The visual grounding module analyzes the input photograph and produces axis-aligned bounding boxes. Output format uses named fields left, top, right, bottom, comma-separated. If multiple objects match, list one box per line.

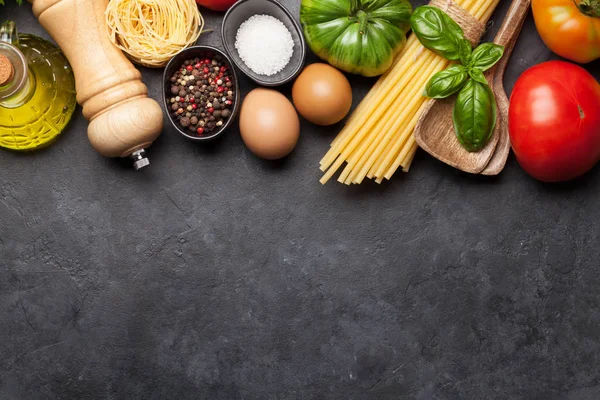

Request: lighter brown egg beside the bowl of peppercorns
left=240, top=88, right=300, bottom=160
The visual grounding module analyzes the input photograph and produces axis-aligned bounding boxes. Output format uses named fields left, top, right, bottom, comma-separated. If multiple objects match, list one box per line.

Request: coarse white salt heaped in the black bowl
left=235, top=14, right=294, bottom=76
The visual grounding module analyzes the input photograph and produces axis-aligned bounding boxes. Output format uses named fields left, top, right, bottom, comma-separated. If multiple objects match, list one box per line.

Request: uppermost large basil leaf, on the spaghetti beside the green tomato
left=410, top=6, right=465, bottom=61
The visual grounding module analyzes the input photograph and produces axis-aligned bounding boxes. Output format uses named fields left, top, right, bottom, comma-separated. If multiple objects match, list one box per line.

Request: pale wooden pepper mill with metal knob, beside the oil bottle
left=29, top=0, right=163, bottom=169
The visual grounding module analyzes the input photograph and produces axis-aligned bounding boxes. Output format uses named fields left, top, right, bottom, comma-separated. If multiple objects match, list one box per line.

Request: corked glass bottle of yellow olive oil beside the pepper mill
left=0, top=21, right=76, bottom=150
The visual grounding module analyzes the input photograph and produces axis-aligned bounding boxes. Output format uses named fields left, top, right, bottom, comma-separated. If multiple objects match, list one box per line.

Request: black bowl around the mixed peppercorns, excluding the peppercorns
left=163, top=46, right=240, bottom=142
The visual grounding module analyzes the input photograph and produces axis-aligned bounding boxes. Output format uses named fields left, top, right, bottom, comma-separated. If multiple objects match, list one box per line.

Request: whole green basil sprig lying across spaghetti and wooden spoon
left=410, top=6, right=504, bottom=152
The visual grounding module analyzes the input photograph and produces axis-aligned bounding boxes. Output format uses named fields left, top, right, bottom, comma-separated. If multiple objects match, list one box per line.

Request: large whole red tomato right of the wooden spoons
left=509, top=61, right=600, bottom=182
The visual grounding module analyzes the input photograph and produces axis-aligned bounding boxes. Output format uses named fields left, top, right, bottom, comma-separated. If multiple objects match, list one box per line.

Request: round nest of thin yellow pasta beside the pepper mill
left=105, top=0, right=204, bottom=68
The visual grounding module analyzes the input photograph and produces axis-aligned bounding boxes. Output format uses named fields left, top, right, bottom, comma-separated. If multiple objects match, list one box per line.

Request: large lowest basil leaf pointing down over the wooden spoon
left=452, top=79, right=497, bottom=152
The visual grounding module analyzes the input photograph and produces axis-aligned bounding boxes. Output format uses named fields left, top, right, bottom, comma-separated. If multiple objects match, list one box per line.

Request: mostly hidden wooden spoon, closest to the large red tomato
left=481, top=0, right=531, bottom=176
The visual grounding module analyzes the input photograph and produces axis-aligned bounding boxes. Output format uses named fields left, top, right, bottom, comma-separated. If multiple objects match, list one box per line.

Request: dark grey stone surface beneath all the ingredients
left=0, top=0, right=600, bottom=400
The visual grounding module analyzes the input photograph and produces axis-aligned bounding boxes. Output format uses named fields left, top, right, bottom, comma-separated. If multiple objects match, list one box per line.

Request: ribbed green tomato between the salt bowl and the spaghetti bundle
left=300, top=0, right=412, bottom=76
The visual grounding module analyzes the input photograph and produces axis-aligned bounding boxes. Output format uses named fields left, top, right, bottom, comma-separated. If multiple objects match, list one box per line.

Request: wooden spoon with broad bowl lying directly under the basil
left=415, top=0, right=531, bottom=174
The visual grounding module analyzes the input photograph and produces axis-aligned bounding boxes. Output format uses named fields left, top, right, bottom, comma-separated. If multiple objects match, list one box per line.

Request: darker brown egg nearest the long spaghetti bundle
left=292, top=63, right=352, bottom=125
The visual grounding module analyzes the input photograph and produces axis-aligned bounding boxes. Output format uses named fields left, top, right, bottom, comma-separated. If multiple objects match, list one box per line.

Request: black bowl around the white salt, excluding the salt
left=221, top=0, right=306, bottom=86
